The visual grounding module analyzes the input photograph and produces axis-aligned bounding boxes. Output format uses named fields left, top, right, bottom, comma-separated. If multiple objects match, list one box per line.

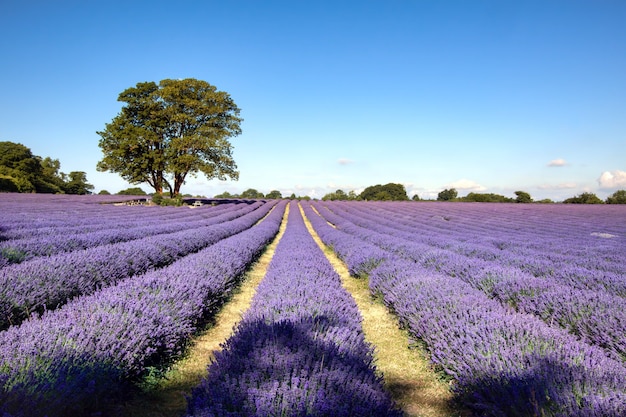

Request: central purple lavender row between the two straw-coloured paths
left=188, top=203, right=401, bottom=417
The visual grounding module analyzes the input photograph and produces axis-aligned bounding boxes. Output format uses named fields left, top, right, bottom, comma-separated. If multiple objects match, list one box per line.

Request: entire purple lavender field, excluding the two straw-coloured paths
left=0, top=194, right=626, bottom=417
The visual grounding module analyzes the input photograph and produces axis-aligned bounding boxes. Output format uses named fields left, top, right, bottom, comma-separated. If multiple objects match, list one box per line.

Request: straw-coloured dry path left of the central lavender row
left=117, top=205, right=289, bottom=417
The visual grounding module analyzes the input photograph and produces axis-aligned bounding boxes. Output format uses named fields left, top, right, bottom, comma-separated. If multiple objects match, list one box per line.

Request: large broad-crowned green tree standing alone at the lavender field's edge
left=97, top=78, right=242, bottom=197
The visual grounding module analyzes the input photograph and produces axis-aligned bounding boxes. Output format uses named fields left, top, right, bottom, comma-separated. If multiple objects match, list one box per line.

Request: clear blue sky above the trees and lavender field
left=0, top=0, right=626, bottom=200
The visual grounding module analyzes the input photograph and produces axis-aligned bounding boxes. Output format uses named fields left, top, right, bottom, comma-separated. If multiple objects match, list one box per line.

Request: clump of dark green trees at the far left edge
left=0, top=142, right=94, bottom=194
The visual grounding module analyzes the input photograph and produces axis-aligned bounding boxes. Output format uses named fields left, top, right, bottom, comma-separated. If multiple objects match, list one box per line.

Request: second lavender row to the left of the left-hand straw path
left=0, top=202, right=273, bottom=330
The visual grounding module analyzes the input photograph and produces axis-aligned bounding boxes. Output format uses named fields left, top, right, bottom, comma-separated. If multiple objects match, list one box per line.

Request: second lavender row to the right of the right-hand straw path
left=320, top=204, right=626, bottom=360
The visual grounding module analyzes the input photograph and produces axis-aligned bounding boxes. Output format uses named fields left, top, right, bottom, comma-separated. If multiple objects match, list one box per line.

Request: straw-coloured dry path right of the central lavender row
left=300, top=204, right=465, bottom=417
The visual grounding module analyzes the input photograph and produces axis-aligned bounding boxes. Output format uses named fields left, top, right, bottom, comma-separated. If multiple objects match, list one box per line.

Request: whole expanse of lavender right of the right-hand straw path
left=305, top=202, right=626, bottom=417
